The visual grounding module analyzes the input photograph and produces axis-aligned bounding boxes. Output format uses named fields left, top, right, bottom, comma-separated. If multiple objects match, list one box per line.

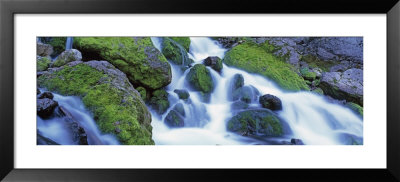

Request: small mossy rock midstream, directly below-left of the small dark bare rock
left=186, top=64, right=214, bottom=94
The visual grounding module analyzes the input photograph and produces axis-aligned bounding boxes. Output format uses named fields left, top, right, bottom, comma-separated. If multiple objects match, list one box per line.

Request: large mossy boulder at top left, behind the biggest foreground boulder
left=74, top=37, right=172, bottom=90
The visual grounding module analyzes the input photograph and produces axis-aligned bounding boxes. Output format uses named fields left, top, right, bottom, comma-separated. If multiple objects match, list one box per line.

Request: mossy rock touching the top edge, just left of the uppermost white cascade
left=162, top=37, right=193, bottom=67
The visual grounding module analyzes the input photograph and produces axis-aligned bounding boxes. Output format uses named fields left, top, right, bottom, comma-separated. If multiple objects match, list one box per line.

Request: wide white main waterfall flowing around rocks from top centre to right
left=151, top=37, right=363, bottom=145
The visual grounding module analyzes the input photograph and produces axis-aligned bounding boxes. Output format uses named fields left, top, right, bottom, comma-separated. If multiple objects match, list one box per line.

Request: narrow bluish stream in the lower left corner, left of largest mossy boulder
left=37, top=90, right=119, bottom=145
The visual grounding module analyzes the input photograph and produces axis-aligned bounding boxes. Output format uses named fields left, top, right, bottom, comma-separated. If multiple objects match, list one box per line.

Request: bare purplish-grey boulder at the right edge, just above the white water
left=319, top=68, right=363, bottom=105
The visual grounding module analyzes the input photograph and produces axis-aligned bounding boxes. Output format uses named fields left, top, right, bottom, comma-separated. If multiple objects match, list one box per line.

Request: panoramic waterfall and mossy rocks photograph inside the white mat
left=36, top=36, right=364, bottom=145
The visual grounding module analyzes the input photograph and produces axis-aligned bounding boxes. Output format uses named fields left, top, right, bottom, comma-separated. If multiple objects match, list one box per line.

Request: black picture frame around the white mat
left=0, top=0, right=400, bottom=181
